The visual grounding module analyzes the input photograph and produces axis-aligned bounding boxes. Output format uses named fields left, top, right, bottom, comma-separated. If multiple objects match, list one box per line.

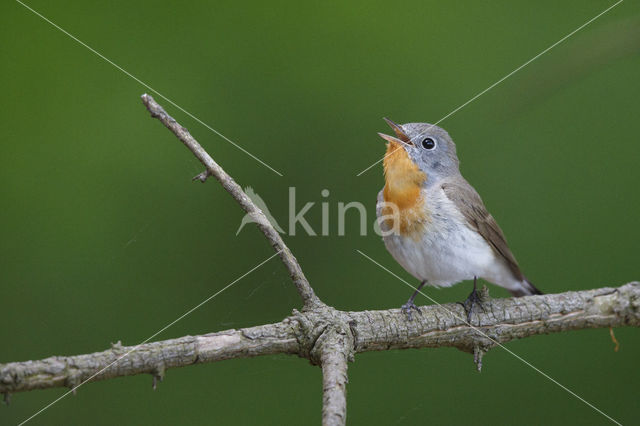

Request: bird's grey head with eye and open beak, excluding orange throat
left=379, top=118, right=460, bottom=183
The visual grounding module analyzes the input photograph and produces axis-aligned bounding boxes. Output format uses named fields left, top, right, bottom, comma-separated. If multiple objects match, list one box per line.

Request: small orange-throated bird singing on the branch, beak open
left=376, top=118, right=542, bottom=322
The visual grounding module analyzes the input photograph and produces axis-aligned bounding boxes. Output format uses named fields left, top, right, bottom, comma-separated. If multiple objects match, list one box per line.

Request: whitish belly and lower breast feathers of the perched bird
left=383, top=187, right=517, bottom=287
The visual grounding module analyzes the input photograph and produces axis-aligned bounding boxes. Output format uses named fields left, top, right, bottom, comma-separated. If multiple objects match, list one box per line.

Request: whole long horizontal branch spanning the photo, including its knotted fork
left=0, top=282, right=640, bottom=396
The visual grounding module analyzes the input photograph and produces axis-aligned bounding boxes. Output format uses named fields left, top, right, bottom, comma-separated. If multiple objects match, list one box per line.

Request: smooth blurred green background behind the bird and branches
left=0, top=0, right=640, bottom=425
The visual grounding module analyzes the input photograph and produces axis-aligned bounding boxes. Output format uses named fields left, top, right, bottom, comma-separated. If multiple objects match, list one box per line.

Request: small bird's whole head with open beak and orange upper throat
left=378, top=118, right=459, bottom=184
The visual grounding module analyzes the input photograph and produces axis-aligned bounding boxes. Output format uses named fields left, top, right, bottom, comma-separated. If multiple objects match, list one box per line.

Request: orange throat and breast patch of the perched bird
left=382, top=142, right=428, bottom=239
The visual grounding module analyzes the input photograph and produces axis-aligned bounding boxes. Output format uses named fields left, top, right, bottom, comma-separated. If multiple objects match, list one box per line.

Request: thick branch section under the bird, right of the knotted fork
left=349, top=282, right=640, bottom=360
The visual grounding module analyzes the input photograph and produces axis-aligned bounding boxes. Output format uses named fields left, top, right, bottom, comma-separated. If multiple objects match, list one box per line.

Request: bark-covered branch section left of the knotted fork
left=0, top=321, right=299, bottom=393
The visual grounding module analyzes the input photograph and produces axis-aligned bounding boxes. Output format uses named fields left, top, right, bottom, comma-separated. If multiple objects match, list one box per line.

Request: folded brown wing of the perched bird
left=442, top=177, right=524, bottom=280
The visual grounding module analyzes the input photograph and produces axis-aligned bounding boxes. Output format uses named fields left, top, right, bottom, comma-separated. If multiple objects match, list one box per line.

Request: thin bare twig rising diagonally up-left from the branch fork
left=142, top=93, right=322, bottom=309
